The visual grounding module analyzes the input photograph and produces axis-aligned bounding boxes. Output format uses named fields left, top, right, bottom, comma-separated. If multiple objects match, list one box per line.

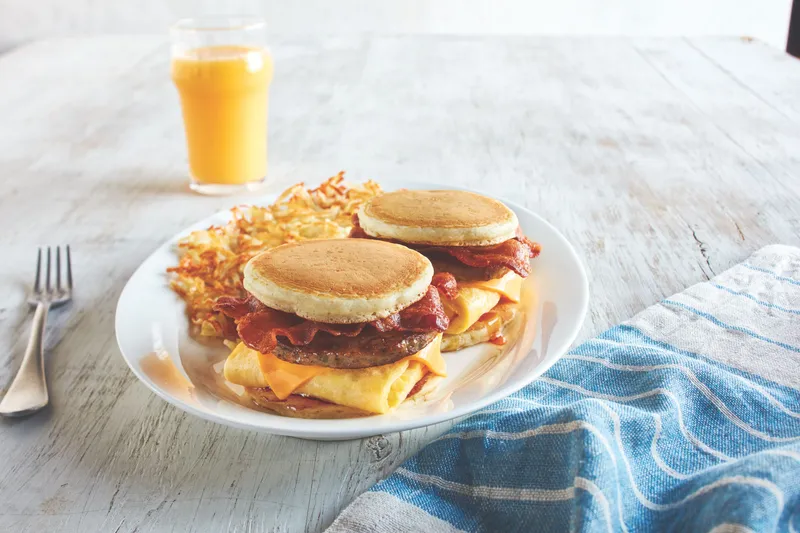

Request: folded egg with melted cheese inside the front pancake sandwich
left=224, top=335, right=447, bottom=413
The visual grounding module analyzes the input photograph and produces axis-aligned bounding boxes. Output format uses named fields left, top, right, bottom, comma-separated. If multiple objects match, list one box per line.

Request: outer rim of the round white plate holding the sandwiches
left=114, top=179, right=589, bottom=440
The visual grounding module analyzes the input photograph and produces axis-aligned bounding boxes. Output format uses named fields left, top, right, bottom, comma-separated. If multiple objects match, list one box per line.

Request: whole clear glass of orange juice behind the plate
left=171, top=16, right=272, bottom=194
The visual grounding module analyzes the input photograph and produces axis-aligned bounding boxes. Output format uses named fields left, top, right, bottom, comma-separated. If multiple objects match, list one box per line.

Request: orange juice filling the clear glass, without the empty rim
left=172, top=46, right=272, bottom=185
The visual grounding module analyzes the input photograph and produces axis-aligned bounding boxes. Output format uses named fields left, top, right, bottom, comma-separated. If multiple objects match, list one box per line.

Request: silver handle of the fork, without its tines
left=0, top=302, right=50, bottom=416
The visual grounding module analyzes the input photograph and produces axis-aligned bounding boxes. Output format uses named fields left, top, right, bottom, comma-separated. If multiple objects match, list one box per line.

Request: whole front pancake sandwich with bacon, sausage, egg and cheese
left=215, top=239, right=449, bottom=418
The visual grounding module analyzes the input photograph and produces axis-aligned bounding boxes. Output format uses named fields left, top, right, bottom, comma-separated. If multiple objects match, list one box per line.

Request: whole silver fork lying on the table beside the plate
left=0, top=246, right=72, bottom=416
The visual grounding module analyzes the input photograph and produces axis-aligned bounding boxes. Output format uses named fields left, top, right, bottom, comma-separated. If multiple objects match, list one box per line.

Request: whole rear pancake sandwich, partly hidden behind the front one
left=350, top=190, right=541, bottom=351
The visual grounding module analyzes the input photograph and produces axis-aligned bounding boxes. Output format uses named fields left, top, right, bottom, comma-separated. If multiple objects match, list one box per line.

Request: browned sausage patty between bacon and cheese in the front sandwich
left=273, top=329, right=438, bottom=368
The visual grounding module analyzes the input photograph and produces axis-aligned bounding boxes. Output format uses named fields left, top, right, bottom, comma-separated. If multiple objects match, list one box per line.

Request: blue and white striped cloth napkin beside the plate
left=328, top=246, right=800, bottom=533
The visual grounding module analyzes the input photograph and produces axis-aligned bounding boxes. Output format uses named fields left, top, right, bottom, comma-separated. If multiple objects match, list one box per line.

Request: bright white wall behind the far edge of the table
left=0, top=0, right=791, bottom=49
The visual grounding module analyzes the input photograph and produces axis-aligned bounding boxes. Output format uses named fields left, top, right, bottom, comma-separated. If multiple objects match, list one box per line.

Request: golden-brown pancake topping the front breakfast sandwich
left=244, top=239, right=433, bottom=324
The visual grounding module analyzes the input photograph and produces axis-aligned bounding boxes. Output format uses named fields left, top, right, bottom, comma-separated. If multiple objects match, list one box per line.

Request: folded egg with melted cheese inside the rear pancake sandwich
left=442, top=272, right=522, bottom=335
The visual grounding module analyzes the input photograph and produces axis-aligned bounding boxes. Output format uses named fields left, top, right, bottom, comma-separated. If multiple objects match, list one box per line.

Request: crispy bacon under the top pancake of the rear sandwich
left=350, top=213, right=542, bottom=278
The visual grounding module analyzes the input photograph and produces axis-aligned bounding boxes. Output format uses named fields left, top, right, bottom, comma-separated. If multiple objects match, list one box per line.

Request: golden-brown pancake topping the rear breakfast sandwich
left=358, top=190, right=519, bottom=246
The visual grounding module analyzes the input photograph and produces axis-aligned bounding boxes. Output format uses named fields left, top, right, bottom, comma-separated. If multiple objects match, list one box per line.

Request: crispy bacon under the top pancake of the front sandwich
left=214, top=286, right=450, bottom=353
